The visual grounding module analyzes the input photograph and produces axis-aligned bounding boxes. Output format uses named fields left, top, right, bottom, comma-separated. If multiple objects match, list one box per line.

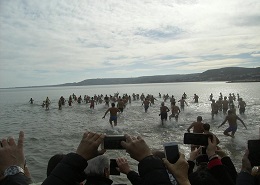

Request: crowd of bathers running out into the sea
left=26, top=92, right=250, bottom=140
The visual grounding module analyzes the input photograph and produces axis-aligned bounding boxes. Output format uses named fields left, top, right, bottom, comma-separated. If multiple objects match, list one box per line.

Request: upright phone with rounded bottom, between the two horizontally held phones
left=163, top=142, right=180, bottom=164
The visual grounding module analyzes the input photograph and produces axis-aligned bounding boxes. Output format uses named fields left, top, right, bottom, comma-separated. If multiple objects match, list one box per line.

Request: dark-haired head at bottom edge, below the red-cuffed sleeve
left=189, top=170, right=220, bottom=185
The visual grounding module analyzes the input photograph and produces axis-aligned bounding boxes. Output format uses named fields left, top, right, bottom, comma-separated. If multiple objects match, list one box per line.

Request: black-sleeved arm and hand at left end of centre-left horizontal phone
left=42, top=132, right=105, bottom=185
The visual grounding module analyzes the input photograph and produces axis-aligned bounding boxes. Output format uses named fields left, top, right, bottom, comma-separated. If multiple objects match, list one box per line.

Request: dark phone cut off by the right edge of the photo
left=247, top=139, right=260, bottom=167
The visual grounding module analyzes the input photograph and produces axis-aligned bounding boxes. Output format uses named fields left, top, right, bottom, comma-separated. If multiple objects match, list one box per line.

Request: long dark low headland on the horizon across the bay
left=6, top=67, right=260, bottom=88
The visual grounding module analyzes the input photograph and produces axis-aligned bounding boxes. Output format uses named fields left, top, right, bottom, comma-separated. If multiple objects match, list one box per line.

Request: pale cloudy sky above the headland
left=0, top=0, right=260, bottom=88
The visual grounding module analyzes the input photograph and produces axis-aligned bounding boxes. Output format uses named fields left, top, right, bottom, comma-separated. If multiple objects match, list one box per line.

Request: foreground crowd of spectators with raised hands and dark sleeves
left=0, top=131, right=260, bottom=185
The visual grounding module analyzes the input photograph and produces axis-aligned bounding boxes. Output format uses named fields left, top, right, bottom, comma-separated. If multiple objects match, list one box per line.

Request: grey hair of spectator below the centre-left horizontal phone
left=84, top=155, right=110, bottom=176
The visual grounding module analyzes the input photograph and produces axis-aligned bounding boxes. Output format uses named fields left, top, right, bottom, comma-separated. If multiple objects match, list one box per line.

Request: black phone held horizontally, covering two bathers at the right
left=183, top=133, right=213, bottom=146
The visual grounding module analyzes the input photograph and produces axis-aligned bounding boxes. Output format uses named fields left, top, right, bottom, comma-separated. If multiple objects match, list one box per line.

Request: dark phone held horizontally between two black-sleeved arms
left=101, top=135, right=126, bottom=150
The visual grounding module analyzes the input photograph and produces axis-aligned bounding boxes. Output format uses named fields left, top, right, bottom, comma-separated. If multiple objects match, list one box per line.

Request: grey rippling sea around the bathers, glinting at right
left=0, top=82, right=260, bottom=184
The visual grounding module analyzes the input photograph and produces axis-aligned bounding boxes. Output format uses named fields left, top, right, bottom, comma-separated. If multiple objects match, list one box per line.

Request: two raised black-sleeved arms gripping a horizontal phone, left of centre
left=42, top=132, right=171, bottom=185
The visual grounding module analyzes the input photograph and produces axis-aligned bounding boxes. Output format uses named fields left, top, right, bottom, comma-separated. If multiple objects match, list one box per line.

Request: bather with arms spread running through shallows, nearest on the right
left=218, top=110, right=247, bottom=138
